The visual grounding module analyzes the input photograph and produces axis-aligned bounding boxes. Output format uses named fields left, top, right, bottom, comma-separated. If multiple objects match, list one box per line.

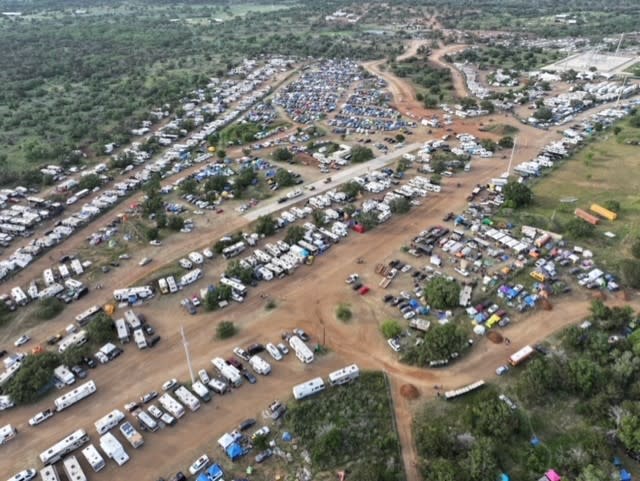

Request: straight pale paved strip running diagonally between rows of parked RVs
left=244, top=142, right=423, bottom=221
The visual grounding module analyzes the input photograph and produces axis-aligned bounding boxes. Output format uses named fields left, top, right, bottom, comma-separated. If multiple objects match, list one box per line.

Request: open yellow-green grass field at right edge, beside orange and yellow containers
left=504, top=121, right=640, bottom=270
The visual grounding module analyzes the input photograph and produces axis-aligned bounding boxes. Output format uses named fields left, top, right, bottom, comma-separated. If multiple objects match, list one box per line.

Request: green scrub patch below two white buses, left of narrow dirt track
left=285, top=372, right=405, bottom=481
